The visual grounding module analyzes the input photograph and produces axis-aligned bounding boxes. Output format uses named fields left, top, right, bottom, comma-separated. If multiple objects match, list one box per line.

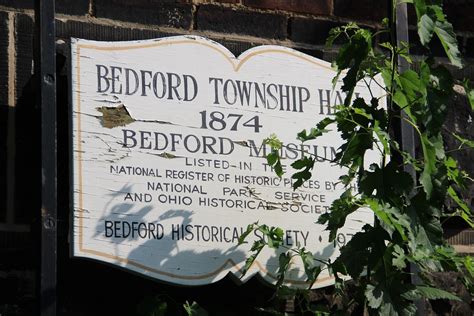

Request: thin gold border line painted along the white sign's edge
left=76, top=39, right=334, bottom=285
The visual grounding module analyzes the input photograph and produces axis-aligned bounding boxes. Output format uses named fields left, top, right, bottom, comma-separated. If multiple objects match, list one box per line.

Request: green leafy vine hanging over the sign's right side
left=240, top=0, right=474, bottom=315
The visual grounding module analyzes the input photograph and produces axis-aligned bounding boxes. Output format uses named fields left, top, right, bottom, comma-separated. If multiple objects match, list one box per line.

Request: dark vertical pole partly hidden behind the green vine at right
left=389, top=1, right=426, bottom=315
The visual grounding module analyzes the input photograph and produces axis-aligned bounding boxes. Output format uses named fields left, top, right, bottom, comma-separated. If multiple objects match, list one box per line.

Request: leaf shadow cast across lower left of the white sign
left=94, top=184, right=247, bottom=285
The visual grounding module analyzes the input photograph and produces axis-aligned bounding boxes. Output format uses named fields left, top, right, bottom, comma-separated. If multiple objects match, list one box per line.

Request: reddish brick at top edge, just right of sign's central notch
left=242, top=0, right=332, bottom=15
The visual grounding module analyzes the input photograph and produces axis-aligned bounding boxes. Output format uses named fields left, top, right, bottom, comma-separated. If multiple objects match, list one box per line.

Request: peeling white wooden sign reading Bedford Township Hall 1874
left=71, top=36, right=382, bottom=287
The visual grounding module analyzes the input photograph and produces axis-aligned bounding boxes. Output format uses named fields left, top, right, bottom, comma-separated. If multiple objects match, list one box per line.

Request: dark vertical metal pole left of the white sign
left=35, top=0, right=57, bottom=316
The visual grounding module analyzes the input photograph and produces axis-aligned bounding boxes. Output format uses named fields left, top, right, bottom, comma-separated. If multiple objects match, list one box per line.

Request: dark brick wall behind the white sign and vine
left=0, top=0, right=474, bottom=313
